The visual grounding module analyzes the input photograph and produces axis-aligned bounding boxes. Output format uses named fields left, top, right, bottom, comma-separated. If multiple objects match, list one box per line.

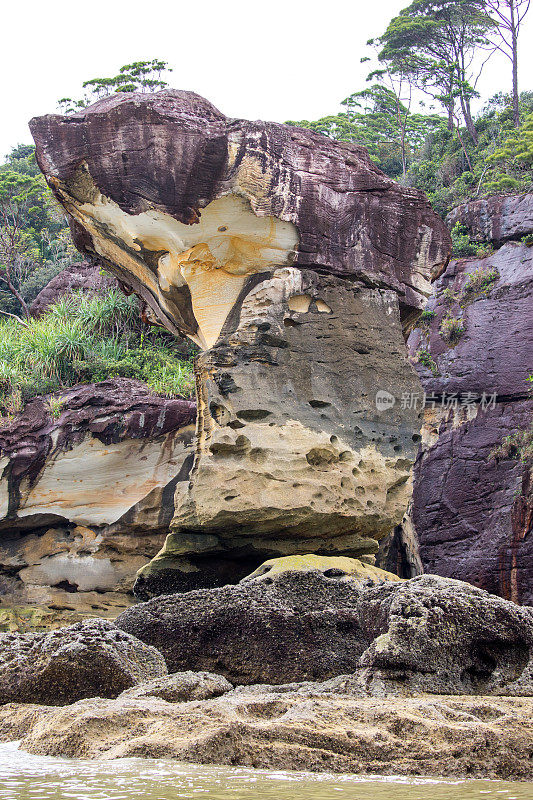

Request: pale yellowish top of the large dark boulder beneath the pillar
left=243, top=554, right=401, bottom=583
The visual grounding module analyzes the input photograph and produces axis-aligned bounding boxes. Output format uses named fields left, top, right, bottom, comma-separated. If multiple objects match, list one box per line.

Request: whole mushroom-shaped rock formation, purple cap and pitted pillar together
left=31, top=91, right=450, bottom=591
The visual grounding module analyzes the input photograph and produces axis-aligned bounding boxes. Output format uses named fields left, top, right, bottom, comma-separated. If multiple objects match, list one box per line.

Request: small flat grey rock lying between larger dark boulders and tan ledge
left=120, top=671, right=233, bottom=703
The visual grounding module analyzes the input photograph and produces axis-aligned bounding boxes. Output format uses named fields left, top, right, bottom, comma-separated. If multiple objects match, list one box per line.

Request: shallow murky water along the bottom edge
left=0, top=743, right=533, bottom=800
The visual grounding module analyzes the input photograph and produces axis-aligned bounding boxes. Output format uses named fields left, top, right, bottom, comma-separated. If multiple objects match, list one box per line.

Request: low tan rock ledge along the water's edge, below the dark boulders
left=0, top=692, right=533, bottom=780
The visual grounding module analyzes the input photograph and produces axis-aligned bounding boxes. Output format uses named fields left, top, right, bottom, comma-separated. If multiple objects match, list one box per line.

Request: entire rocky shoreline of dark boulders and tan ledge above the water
left=0, top=559, right=533, bottom=780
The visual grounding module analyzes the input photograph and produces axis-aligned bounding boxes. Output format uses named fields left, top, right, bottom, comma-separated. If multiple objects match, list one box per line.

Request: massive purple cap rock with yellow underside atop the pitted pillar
left=30, top=89, right=449, bottom=328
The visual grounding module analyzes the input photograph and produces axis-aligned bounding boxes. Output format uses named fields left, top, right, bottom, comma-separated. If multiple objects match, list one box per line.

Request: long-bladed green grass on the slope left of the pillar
left=0, top=290, right=193, bottom=419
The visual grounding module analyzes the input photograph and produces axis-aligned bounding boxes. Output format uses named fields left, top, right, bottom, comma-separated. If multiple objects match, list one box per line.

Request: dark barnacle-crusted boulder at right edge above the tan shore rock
left=360, top=575, right=533, bottom=695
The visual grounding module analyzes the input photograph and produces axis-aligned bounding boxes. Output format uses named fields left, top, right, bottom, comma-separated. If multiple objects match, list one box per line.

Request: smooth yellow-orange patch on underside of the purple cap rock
left=57, top=174, right=298, bottom=348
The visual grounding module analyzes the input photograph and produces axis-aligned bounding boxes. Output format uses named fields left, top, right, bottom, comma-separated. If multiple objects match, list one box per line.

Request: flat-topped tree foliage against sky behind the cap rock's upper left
left=57, top=58, right=172, bottom=114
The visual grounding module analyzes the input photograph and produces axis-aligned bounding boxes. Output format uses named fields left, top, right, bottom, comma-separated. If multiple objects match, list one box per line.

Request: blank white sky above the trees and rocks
left=0, top=0, right=533, bottom=157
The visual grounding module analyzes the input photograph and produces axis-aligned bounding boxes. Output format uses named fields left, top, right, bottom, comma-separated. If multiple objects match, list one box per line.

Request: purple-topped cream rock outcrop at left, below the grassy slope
left=0, top=379, right=196, bottom=627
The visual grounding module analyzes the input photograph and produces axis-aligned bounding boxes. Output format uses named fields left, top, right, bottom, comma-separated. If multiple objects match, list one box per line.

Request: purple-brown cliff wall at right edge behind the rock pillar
left=404, top=203, right=533, bottom=605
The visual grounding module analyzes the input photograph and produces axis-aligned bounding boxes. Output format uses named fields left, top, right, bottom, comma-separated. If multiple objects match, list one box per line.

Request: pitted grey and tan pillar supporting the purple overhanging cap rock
left=135, top=268, right=421, bottom=599
